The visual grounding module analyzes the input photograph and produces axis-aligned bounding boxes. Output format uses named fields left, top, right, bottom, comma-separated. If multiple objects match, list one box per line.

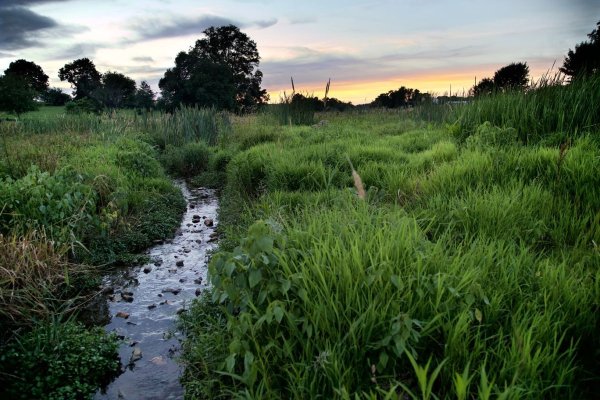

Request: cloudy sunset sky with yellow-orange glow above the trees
left=0, top=0, right=600, bottom=104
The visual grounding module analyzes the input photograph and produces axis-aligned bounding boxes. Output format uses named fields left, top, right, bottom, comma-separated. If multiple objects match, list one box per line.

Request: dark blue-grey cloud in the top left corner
left=0, top=7, right=59, bottom=50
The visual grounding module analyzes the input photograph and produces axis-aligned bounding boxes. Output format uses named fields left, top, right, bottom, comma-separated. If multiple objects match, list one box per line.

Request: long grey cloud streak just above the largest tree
left=128, top=15, right=277, bottom=42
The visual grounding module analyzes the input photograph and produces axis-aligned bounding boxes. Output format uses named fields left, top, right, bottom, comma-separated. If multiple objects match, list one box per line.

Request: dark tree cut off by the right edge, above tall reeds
left=560, top=21, right=600, bottom=78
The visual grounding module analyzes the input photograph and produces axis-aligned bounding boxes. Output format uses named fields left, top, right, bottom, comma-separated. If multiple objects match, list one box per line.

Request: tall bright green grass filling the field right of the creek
left=182, top=81, right=600, bottom=399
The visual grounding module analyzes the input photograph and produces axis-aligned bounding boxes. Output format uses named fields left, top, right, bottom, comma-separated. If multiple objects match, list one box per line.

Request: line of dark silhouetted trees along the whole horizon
left=0, top=21, right=600, bottom=114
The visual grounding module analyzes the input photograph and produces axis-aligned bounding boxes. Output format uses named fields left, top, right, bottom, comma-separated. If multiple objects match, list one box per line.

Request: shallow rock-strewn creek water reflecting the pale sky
left=94, top=182, right=217, bottom=400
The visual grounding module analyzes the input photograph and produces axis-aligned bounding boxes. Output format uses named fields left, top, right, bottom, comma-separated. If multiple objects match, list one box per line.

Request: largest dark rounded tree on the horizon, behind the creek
left=159, top=25, right=268, bottom=111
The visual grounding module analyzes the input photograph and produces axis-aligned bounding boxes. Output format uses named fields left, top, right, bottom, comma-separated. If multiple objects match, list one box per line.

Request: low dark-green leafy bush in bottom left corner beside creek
left=0, top=321, right=119, bottom=400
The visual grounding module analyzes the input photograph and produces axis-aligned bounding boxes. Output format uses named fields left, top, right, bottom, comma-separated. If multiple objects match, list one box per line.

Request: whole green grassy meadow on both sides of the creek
left=0, top=77, right=600, bottom=399
